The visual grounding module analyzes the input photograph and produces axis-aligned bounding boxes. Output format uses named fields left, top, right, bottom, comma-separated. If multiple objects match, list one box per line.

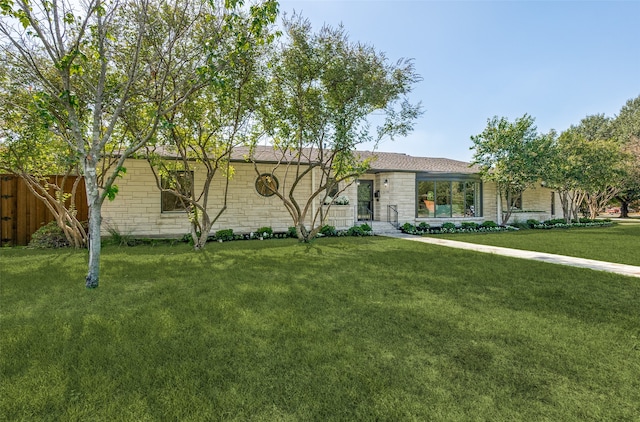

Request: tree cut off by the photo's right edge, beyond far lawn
left=613, top=96, right=640, bottom=218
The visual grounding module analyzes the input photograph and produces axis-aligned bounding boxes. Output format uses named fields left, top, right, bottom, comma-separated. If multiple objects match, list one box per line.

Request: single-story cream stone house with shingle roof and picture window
left=102, top=146, right=561, bottom=237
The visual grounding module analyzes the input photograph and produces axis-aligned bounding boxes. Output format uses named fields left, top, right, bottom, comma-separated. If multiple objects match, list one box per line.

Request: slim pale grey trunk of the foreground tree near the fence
left=85, top=163, right=102, bottom=289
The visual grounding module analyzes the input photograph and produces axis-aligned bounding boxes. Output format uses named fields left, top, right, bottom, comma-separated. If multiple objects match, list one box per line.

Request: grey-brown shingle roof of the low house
left=146, top=145, right=480, bottom=174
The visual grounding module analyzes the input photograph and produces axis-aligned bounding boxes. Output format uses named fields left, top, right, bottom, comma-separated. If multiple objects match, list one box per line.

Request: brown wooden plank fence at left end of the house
left=0, top=175, right=89, bottom=246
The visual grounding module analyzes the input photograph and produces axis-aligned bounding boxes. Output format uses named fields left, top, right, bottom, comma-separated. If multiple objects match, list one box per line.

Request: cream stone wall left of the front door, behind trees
left=102, top=159, right=356, bottom=237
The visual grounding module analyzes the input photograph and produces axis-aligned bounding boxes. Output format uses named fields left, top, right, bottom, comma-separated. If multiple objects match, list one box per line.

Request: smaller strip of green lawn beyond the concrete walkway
left=436, top=224, right=640, bottom=266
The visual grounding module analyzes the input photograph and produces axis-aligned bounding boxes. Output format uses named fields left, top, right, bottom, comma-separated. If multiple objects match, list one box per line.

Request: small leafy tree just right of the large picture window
left=471, top=114, right=555, bottom=223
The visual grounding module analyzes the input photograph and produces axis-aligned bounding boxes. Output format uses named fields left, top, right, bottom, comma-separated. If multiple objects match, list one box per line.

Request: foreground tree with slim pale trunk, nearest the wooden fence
left=0, top=0, right=228, bottom=288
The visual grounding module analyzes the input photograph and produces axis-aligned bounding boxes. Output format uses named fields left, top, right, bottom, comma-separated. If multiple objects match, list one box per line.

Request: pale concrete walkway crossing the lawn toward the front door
left=383, top=233, right=640, bottom=278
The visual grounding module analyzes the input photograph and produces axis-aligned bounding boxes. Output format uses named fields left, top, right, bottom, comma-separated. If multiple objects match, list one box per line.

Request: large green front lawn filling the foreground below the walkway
left=0, top=238, right=640, bottom=421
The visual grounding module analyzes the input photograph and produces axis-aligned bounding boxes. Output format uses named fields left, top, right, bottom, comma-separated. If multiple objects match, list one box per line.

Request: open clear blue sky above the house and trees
left=280, top=0, right=640, bottom=161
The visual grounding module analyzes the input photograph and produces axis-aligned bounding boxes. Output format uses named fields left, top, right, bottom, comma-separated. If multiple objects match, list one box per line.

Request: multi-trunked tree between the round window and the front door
left=253, top=16, right=421, bottom=242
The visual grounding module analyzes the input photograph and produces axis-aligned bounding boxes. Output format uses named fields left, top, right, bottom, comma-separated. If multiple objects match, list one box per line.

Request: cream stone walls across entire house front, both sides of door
left=102, top=159, right=562, bottom=237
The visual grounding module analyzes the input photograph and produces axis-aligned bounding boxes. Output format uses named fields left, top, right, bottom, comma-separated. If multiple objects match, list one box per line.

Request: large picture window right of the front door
left=417, top=178, right=482, bottom=218
